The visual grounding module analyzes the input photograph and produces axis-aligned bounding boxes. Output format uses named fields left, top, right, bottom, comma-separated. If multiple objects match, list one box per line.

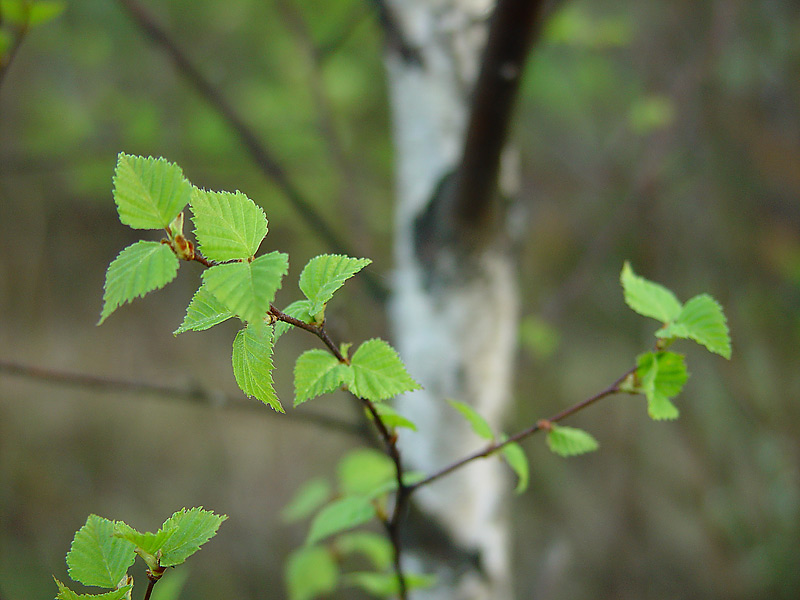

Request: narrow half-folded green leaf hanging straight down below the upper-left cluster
left=233, top=323, right=285, bottom=412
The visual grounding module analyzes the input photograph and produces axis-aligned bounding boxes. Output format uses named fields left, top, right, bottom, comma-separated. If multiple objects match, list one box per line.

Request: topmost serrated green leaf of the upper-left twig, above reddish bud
left=114, top=152, right=192, bottom=229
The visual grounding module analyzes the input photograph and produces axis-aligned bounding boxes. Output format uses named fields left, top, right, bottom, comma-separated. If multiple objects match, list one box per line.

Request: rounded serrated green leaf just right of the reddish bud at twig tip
left=190, top=188, right=268, bottom=261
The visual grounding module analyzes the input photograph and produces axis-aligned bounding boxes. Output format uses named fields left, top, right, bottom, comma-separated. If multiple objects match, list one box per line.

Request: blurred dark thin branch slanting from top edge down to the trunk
left=119, top=0, right=388, bottom=302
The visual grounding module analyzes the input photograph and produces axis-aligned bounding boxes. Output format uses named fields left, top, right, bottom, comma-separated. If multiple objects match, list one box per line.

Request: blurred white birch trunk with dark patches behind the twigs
left=387, top=0, right=518, bottom=600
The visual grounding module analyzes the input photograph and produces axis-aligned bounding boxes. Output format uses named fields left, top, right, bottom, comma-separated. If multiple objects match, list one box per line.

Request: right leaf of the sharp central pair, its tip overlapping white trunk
left=349, top=338, right=420, bottom=402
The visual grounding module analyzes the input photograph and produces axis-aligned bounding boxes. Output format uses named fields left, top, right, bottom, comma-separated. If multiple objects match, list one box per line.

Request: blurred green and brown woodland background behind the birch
left=0, top=0, right=800, bottom=600
